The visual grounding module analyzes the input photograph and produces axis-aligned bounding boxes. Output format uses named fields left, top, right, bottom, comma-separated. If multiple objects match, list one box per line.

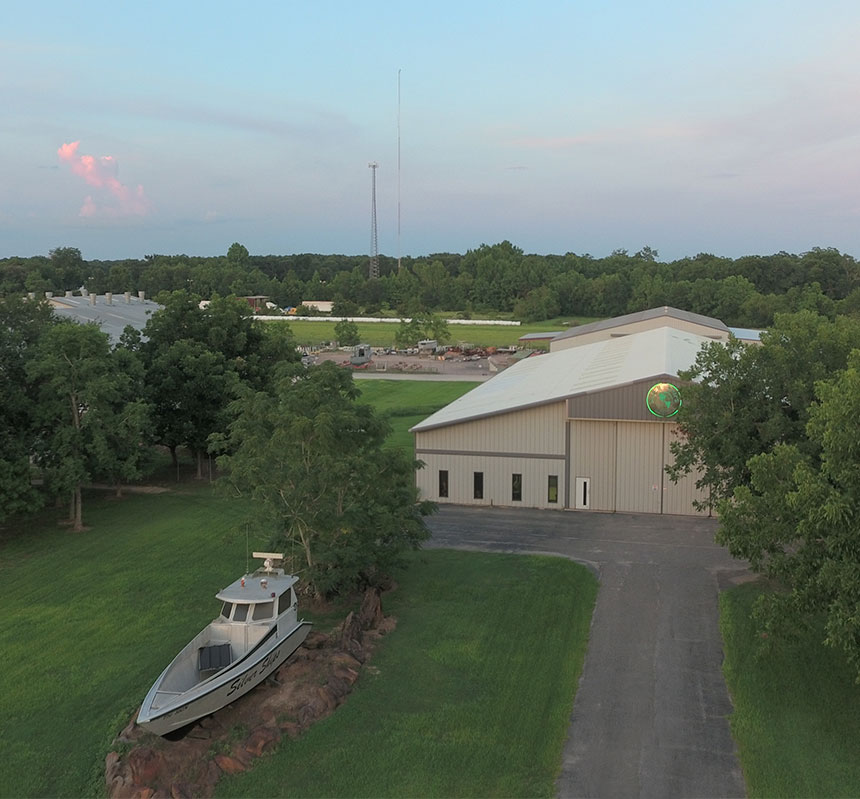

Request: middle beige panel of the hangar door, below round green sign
left=615, top=422, right=664, bottom=513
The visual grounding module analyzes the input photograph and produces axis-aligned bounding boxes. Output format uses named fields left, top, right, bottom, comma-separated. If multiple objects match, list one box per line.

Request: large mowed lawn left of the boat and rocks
left=0, top=486, right=268, bottom=796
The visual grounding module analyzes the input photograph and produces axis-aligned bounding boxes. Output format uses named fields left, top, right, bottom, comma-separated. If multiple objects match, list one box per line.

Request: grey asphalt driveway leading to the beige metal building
left=429, top=505, right=747, bottom=799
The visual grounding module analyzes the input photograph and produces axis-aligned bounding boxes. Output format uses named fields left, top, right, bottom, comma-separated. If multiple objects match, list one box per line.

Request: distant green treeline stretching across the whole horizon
left=0, top=241, right=860, bottom=327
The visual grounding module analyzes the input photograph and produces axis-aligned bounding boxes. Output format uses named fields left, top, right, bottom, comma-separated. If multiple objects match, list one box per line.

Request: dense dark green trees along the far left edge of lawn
left=0, top=292, right=298, bottom=530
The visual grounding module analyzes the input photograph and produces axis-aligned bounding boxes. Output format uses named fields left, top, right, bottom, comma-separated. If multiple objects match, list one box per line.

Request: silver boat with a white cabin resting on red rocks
left=137, top=552, right=312, bottom=735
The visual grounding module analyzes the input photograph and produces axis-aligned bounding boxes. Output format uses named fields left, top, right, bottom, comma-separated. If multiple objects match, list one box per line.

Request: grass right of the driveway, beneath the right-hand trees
left=720, top=584, right=860, bottom=797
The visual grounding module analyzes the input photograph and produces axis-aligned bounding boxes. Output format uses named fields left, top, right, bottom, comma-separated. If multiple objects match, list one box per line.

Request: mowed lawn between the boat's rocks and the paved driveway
left=217, top=550, right=597, bottom=797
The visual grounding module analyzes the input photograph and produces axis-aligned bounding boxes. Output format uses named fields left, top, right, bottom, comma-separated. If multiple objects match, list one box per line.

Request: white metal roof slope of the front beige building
left=411, top=327, right=713, bottom=432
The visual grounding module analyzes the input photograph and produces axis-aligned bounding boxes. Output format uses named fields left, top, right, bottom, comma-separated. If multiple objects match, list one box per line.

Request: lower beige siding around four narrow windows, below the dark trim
left=417, top=454, right=565, bottom=508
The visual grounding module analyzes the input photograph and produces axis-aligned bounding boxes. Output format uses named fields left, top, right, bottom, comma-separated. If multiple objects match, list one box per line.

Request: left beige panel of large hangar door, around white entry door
left=569, top=419, right=616, bottom=511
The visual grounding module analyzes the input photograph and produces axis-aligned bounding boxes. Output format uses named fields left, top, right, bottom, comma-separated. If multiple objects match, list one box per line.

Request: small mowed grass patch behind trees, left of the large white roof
left=355, top=378, right=480, bottom=452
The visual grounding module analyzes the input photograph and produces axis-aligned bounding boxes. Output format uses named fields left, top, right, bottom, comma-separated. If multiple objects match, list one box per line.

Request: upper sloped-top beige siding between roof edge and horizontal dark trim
left=415, top=400, right=567, bottom=455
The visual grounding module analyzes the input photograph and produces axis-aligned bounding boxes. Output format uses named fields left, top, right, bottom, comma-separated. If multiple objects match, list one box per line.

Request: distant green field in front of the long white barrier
left=266, top=319, right=593, bottom=347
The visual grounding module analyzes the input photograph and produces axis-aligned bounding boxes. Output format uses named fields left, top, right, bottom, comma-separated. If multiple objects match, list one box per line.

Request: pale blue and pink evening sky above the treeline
left=0, top=0, right=860, bottom=260
